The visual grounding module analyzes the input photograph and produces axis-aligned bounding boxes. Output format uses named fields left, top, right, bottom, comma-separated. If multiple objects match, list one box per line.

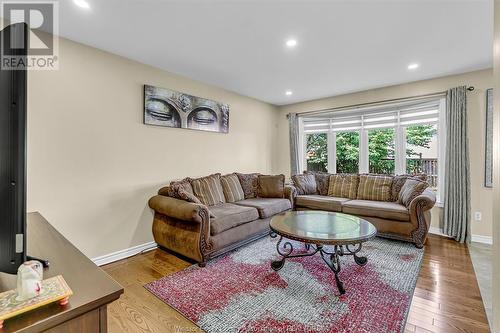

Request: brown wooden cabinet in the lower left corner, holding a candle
left=0, top=213, right=123, bottom=333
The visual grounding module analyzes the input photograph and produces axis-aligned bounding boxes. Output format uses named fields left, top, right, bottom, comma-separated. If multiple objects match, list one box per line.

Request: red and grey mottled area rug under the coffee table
left=145, top=237, right=423, bottom=333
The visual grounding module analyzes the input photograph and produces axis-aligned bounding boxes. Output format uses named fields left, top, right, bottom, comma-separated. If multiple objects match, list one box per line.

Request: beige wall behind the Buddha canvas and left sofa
left=28, top=39, right=278, bottom=257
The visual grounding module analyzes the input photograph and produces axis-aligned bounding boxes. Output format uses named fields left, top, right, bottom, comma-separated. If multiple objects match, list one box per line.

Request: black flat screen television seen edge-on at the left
left=0, top=23, right=28, bottom=274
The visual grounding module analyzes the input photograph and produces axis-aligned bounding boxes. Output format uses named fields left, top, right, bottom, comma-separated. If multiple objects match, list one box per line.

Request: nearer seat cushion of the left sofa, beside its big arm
left=210, top=203, right=259, bottom=236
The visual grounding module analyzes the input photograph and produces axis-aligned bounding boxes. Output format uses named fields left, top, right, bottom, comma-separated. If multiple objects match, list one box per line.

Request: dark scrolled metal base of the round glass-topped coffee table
left=271, top=233, right=368, bottom=295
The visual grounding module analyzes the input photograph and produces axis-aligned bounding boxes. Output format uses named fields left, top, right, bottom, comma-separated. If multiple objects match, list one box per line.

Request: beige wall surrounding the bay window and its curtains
left=275, top=69, right=493, bottom=236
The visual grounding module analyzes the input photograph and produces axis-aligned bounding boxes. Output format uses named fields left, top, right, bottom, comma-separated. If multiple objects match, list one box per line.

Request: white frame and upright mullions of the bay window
left=299, top=97, right=446, bottom=202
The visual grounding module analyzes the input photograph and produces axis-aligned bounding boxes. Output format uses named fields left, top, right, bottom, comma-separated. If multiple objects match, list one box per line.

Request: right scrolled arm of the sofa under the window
left=409, top=189, right=436, bottom=248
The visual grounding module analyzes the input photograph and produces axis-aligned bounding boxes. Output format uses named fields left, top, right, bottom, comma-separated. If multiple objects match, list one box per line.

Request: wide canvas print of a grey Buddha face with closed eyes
left=144, top=85, right=229, bottom=133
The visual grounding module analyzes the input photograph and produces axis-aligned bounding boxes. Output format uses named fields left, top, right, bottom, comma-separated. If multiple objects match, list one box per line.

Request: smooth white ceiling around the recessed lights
left=54, top=0, right=493, bottom=105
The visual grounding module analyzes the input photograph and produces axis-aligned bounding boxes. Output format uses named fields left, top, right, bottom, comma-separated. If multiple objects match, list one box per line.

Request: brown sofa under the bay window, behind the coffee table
left=292, top=172, right=436, bottom=248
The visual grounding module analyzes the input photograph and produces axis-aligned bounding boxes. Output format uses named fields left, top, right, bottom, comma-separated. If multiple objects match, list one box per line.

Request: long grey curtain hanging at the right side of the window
left=443, top=86, right=471, bottom=243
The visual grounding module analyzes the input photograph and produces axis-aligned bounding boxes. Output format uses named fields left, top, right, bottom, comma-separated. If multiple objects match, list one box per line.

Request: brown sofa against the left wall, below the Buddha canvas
left=149, top=173, right=294, bottom=266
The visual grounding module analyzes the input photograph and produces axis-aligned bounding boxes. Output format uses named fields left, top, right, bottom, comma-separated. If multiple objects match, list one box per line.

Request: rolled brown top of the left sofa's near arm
left=149, top=195, right=208, bottom=223
